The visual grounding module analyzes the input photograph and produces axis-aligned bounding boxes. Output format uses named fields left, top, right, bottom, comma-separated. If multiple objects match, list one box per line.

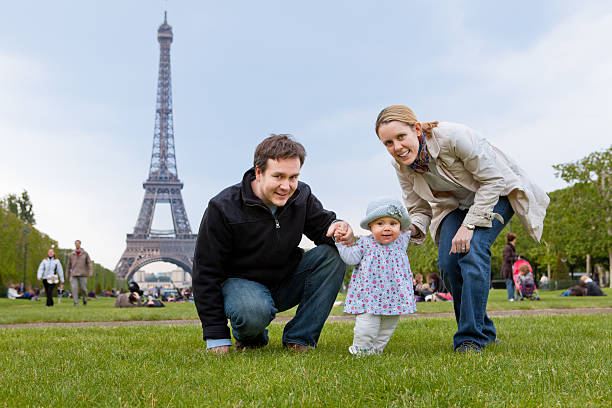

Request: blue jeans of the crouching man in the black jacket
left=222, top=245, right=346, bottom=347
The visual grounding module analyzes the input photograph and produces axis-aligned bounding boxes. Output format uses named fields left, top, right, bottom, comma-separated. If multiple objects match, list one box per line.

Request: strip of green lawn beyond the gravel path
left=0, top=289, right=612, bottom=324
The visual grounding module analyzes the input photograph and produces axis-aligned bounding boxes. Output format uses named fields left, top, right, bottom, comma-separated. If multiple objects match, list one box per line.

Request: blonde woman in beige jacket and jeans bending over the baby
left=376, top=105, right=549, bottom=352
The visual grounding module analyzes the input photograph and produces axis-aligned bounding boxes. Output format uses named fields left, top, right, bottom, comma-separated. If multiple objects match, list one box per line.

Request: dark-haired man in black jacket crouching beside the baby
left=193, top=135, right=353, bottom=354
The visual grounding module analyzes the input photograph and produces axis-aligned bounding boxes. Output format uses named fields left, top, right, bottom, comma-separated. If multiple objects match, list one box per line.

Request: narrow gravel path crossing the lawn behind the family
left=0, top=307, right=612, bottom=329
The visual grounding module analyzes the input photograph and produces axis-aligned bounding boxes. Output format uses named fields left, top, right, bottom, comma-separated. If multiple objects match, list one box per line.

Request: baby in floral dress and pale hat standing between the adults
left=334, top=198, right=416, bottom=355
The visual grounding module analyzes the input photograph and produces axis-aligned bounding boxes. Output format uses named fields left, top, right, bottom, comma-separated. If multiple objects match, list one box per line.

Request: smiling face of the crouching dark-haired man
left=253, top=157, right=301, bottom=207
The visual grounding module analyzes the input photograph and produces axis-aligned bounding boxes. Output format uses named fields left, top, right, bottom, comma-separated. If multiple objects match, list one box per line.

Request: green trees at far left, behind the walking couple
left=0, top=190, right=118, bottom=294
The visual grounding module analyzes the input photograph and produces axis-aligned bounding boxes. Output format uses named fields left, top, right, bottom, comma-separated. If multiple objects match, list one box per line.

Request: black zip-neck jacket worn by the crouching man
left=193, top=168, right=336, bottom=339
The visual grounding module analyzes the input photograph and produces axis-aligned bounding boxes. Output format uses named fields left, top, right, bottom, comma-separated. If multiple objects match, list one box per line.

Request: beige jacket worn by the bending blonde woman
left=393, top=122, right=550, bottom=245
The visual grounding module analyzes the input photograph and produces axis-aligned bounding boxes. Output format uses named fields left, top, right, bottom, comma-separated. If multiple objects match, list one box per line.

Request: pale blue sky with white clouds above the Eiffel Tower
left=0, top=0, right=612, bottom=269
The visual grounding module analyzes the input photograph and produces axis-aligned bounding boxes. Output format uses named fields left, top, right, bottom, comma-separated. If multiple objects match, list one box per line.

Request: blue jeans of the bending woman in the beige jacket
left=438, top=197, right=514, bottom=349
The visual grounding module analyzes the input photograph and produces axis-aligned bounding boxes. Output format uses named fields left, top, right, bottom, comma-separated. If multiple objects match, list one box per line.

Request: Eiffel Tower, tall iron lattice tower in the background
left=115, top=13, right=197, bottom=279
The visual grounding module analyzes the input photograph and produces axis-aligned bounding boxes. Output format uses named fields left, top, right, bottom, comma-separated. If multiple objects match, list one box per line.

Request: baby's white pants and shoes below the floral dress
left=349, top=313, right=400, bottom=354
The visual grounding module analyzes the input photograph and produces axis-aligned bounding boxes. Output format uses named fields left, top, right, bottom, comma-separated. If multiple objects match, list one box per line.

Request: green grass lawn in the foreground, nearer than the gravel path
left=0, top=314, right=612, bottom=407
